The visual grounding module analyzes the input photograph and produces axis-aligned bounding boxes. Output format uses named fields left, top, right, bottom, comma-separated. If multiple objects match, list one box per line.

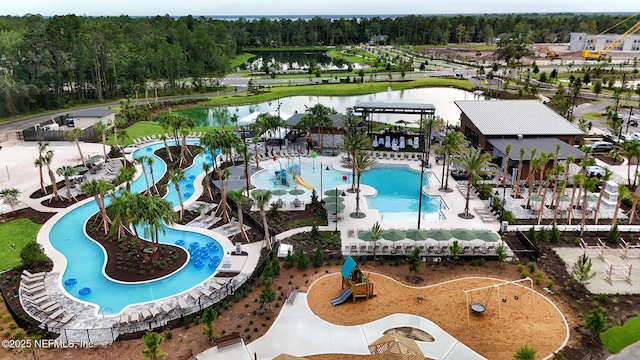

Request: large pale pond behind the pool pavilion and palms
left=179, top=88, right=484, bottom=126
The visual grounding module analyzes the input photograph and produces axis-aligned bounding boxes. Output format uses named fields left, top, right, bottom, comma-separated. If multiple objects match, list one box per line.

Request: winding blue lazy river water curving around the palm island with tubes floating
left=49, top=142, right=224, bottom=313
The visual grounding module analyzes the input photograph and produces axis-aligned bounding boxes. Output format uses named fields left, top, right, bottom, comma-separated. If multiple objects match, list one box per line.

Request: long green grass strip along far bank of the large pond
left=200, top=78, right=473, bottom=106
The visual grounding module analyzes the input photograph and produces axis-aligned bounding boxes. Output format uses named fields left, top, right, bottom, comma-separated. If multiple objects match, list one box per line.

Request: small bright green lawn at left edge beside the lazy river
left=0, top=219, right=42, bottom=271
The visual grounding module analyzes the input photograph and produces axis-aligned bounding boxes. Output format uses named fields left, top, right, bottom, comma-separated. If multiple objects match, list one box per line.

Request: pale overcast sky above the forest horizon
left=0, top=0, right=640, bottom=16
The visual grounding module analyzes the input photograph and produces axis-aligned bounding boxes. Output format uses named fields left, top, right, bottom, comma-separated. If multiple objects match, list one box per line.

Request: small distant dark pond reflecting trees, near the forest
left=238, top=51, right=362, bottom=72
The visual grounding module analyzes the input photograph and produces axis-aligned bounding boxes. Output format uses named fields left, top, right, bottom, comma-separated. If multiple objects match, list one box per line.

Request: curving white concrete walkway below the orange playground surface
left=197, top=293, right=485, bottom=360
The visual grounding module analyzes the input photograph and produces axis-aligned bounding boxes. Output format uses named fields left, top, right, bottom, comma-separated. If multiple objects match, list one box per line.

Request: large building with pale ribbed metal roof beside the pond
left=454, top=100, right=585, bottom=180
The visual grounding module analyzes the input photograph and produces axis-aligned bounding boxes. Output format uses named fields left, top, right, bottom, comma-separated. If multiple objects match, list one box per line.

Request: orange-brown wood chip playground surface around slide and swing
left=307, top=272, right=569, bottom=360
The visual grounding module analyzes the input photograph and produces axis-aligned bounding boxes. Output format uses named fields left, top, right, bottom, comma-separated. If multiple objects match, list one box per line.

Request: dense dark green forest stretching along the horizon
left=0, top=14, right=637, bottom=117
